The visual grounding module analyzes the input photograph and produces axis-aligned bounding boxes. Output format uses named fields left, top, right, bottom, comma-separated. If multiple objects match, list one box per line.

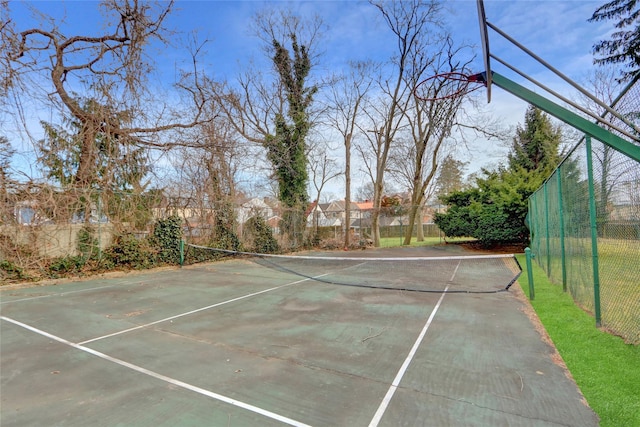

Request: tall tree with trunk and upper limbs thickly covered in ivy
left=210, top=8, right=324, bottom=246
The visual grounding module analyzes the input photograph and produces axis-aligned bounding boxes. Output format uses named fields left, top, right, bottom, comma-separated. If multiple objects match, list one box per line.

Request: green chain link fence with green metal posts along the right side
left=529, top=79, right=640, bottom=345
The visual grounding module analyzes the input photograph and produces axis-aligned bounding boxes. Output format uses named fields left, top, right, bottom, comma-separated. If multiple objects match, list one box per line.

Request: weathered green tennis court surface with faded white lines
left=0, top=248, right=598, bottom=427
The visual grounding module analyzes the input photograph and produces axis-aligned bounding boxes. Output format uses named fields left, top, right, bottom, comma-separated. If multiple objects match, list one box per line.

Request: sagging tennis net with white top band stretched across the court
left=188, top=245, right=522, bottom=293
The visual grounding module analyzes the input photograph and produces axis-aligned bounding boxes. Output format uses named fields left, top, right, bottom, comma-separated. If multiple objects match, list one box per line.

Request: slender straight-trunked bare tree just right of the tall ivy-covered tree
left=326, top=61, right=376, bottom=248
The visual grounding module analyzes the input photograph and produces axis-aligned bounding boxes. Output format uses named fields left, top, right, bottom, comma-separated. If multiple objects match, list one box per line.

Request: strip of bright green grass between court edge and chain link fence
left=518, top=255, right=640, bottom=427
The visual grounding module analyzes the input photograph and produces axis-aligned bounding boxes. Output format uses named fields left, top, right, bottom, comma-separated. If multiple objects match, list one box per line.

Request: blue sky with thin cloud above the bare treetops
left=5, top=0, right=613, bottom=195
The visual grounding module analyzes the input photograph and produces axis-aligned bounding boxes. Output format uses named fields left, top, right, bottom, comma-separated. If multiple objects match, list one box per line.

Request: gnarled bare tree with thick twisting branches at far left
left=0, top=0, right=212, bottom=187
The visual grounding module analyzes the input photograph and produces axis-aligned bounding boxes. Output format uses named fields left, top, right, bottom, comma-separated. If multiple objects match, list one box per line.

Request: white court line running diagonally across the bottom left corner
left=0, top=316, right=310, bottom=427
